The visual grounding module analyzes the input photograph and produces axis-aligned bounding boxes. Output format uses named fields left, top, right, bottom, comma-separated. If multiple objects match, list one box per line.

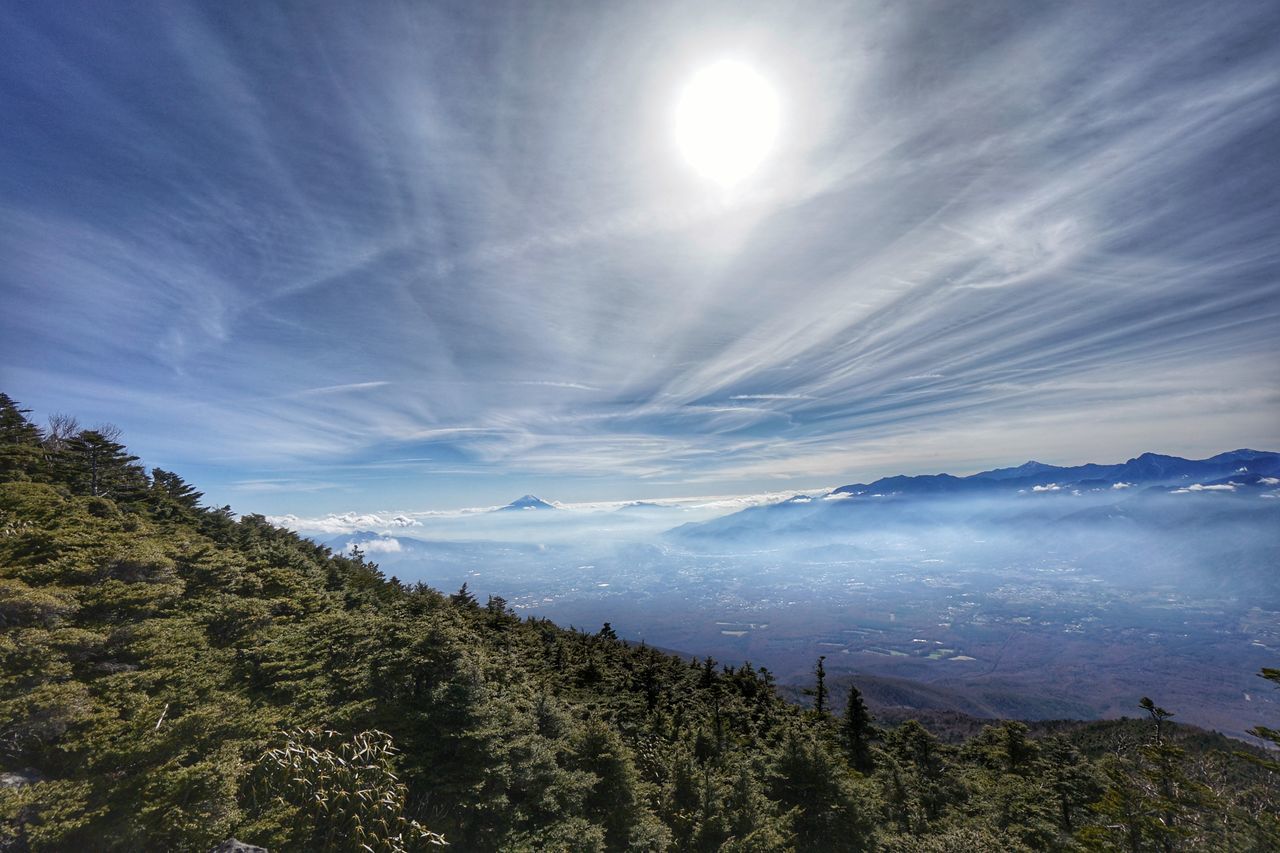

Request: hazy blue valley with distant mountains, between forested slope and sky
left=282, top=451, right=1280, bottom=736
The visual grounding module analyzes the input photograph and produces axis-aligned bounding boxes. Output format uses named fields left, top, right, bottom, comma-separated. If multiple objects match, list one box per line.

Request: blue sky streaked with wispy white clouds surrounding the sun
left=0, top=0, right=1280, bottom=514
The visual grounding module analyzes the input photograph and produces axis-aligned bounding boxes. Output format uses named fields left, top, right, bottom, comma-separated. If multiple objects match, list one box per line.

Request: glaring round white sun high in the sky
left=675, top=60, right=778, bottom=187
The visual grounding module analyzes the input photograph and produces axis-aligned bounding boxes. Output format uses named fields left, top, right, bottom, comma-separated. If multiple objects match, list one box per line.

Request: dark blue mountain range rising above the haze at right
left=668, top=450, right=1280, bottom=543
